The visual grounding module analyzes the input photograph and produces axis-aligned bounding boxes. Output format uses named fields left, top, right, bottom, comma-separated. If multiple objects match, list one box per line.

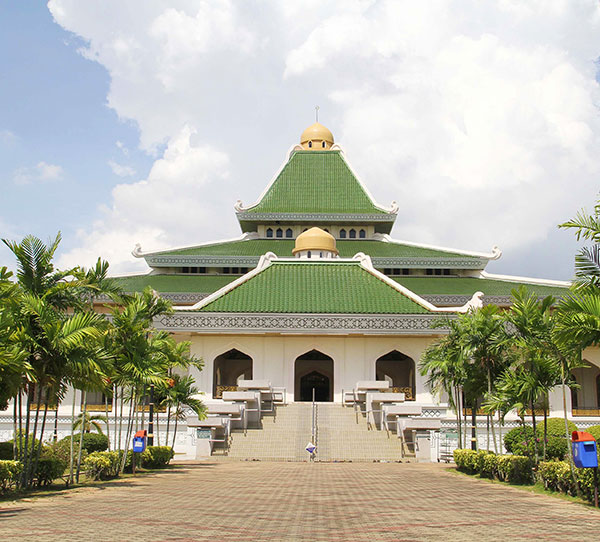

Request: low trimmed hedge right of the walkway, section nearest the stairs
left=454, top=449, right=533, bottom=484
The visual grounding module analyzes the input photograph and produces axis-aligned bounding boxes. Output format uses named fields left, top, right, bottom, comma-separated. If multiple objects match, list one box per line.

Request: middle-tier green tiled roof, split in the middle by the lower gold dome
left=154, top=240, right=480, bottom=262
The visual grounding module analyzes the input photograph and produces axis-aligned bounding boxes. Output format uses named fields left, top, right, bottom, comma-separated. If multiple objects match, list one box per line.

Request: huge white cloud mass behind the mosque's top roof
left=49, top=0, right=600, bottom=275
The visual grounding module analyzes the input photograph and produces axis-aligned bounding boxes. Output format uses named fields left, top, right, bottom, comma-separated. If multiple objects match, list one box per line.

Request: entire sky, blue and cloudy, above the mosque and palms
left=0, top=0, right=600, bottom=279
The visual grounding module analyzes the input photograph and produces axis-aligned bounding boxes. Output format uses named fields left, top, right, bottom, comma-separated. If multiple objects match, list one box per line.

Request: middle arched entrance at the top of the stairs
left=294, top=350, right=333, bottom=402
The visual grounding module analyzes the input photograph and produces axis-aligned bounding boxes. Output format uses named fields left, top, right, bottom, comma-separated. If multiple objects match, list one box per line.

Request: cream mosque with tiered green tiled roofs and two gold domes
left=115, top=123, right=600, bottom=438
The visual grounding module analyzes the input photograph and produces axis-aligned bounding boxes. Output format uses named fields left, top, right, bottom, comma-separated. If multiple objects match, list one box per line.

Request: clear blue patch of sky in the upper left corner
left=0, top=2, right=152, bottom=259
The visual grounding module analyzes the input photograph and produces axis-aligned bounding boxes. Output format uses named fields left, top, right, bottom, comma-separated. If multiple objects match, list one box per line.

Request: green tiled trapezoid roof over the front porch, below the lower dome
left=200, top=261, right=428, bottom=314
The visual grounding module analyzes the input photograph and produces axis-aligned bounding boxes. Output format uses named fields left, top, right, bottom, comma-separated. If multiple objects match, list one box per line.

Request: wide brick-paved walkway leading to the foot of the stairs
left=0, top=462, right=600, bottom=542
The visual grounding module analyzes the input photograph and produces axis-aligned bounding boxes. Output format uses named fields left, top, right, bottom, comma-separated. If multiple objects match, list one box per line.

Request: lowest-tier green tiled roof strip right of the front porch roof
left=392, top=277, right=567, bottom=296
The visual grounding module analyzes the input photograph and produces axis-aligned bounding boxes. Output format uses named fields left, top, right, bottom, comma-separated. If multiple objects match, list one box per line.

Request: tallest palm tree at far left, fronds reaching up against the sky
left=3, top=233, right=111, bottom=487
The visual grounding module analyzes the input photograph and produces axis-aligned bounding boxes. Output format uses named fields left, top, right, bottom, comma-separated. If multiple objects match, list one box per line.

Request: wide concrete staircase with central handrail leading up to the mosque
left=223, top=403, right=410, bottom=461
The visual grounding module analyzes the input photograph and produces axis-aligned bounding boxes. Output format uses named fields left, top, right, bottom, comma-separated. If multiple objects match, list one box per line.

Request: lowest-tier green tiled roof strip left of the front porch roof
left=117, top=275, right=237, bottom=294
